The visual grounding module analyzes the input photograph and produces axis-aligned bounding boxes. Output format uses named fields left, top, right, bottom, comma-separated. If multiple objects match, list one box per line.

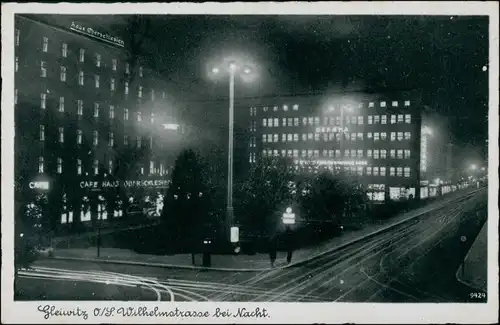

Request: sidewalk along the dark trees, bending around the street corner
left=50, top=187, right=480, bottom=272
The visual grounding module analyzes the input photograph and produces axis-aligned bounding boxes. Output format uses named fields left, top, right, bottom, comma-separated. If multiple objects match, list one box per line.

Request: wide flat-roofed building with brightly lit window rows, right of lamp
left=240, top=91, right=421, bottom=201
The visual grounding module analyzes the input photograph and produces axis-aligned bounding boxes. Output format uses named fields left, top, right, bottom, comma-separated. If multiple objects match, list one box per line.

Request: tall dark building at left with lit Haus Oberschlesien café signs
left=14, top=15, right=182, bottom=233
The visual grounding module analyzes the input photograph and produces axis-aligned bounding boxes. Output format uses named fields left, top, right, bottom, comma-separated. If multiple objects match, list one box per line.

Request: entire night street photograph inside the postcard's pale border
left=12, top=14, right=489, bottom=303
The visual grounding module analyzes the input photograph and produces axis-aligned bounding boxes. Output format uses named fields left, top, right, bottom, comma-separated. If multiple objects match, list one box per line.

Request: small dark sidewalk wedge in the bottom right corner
left=456, top=222, right=488, bottom=292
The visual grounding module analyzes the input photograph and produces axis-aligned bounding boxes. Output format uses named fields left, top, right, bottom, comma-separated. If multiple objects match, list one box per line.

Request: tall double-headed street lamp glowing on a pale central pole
left=212, top=61, right=252, bottom=240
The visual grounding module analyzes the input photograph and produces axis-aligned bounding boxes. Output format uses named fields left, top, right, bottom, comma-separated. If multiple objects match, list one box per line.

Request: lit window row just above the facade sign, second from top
left=262, top=114, right=411, bottom=127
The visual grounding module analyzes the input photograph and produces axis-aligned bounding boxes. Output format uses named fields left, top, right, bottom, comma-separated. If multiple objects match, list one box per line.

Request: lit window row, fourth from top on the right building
left=262, top=149, right=411, bottom=159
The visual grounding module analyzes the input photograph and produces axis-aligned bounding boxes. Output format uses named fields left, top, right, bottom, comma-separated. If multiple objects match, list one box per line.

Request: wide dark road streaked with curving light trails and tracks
left=16, top=189, right=487, bottom=302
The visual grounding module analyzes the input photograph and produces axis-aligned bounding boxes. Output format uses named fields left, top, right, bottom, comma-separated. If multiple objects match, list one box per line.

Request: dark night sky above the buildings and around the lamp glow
left=53, top=15, right=488, bottom=160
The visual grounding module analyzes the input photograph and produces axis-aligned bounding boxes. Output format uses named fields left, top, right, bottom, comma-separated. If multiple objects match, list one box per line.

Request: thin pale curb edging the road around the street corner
left=49, top=188, right=487, bottom=272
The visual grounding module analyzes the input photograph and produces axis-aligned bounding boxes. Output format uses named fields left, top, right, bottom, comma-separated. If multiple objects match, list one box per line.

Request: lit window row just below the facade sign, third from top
left=260, top=132, right=411, bottom=143
